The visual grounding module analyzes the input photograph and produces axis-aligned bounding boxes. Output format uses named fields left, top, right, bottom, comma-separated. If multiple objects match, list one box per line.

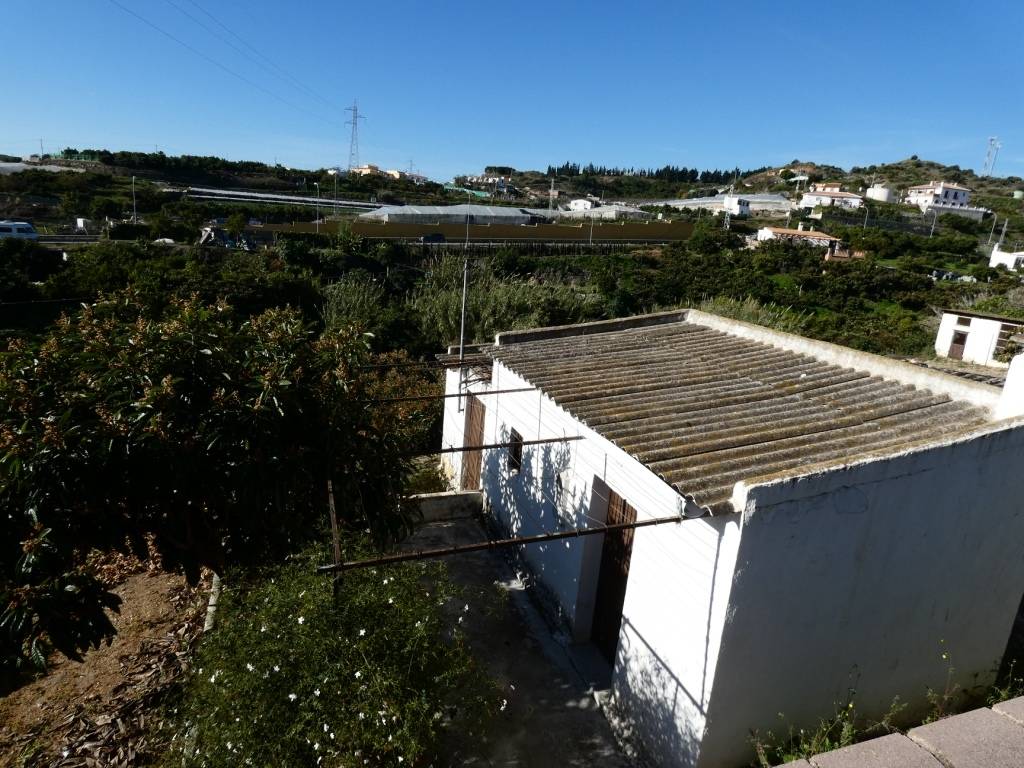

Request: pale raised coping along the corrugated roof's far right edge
left=687, top=309, right=1002, bottom=419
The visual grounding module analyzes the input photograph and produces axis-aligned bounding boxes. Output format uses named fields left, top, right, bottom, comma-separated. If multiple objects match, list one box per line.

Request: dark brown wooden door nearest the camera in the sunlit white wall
left=591, top=489, right=637, bottom=664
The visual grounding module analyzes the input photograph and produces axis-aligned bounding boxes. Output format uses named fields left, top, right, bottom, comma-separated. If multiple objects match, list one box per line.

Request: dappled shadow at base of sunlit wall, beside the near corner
left=614, top=616, right=706, bottom=768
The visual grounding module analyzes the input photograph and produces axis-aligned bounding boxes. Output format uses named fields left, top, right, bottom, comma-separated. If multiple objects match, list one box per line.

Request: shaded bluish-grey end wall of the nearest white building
left=697, top=428, right=1024, bottom=768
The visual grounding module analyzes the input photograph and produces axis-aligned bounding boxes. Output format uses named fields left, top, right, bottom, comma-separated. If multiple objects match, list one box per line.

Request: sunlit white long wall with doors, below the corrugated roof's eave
left=443, top=362, right=739, bottom=766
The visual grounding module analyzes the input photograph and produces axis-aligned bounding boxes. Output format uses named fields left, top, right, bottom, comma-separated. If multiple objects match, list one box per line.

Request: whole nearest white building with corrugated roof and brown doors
left=443, top=310, right=1024, bottom=768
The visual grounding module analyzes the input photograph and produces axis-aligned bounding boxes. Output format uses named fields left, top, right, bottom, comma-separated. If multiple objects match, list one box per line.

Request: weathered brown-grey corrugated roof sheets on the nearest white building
left=489, top=322, right=988, bottom=512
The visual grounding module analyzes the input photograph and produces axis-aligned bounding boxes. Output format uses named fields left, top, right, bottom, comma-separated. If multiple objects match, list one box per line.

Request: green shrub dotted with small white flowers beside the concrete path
left=167, top=553, right=500, bottom=768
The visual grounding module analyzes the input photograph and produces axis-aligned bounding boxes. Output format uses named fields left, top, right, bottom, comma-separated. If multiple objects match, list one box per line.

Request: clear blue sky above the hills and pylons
left=8, top=0, right=1024, bottom=179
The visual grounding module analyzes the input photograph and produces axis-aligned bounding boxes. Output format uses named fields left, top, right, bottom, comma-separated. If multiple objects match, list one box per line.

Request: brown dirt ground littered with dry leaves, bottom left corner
left=0, top=570, right=205, bottom=768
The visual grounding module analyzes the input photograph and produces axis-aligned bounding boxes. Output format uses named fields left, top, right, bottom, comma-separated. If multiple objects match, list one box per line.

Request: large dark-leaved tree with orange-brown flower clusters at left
left=0, top=293, right=426, bottom=676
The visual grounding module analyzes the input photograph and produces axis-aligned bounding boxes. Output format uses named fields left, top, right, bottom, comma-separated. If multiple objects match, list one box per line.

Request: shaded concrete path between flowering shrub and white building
left=404, top=519, right=630, bottom=768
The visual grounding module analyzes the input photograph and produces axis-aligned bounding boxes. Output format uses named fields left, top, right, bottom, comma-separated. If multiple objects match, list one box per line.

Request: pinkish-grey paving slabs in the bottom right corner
left=774, top=696, right=1024, bottom=768
